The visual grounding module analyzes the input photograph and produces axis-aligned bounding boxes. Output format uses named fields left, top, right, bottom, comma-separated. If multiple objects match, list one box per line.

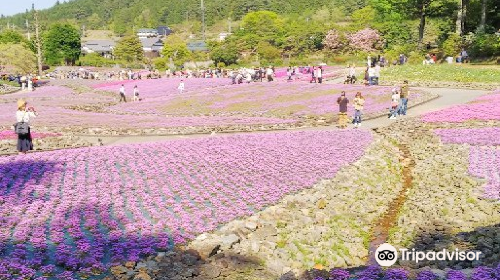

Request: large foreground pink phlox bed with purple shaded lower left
left=0, top=130, right=372, bottom=272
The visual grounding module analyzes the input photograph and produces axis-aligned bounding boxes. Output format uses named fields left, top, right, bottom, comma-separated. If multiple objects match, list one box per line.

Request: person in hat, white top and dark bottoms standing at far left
left=15, top=99, right=38, bottom=155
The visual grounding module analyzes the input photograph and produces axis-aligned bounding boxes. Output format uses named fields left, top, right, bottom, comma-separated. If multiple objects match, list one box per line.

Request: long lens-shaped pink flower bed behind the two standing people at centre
left=109, top=81, right=421, bottom=118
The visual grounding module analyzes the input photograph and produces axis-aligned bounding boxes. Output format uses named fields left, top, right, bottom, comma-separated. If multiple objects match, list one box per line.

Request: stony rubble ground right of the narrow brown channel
left=378, top=119, right=500, bottom=269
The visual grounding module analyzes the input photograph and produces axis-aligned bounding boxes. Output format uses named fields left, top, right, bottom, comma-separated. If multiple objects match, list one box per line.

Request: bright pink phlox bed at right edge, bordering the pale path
left=422, top=90, right=500, bottom=123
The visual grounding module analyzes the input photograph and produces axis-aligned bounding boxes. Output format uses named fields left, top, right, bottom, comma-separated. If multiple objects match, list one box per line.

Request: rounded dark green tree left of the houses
left=43, top=24, right=81, bottom=65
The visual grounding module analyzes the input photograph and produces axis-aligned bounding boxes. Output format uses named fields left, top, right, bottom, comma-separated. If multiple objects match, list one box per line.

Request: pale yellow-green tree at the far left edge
left=0, top=43, right=36, bottom=73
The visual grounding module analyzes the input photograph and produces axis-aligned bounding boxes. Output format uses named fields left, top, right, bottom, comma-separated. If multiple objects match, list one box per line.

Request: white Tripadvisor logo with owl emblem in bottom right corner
left=375, top=243, right=481, bottom=266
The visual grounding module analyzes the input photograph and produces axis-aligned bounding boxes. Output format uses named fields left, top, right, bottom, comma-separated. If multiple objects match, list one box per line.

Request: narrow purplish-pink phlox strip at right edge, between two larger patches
left=434, top=127, right=500, bottom=145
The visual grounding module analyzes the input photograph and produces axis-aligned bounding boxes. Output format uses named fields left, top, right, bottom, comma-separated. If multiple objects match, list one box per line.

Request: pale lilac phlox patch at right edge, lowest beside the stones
left=469, top=146, right=500, bottom=201
